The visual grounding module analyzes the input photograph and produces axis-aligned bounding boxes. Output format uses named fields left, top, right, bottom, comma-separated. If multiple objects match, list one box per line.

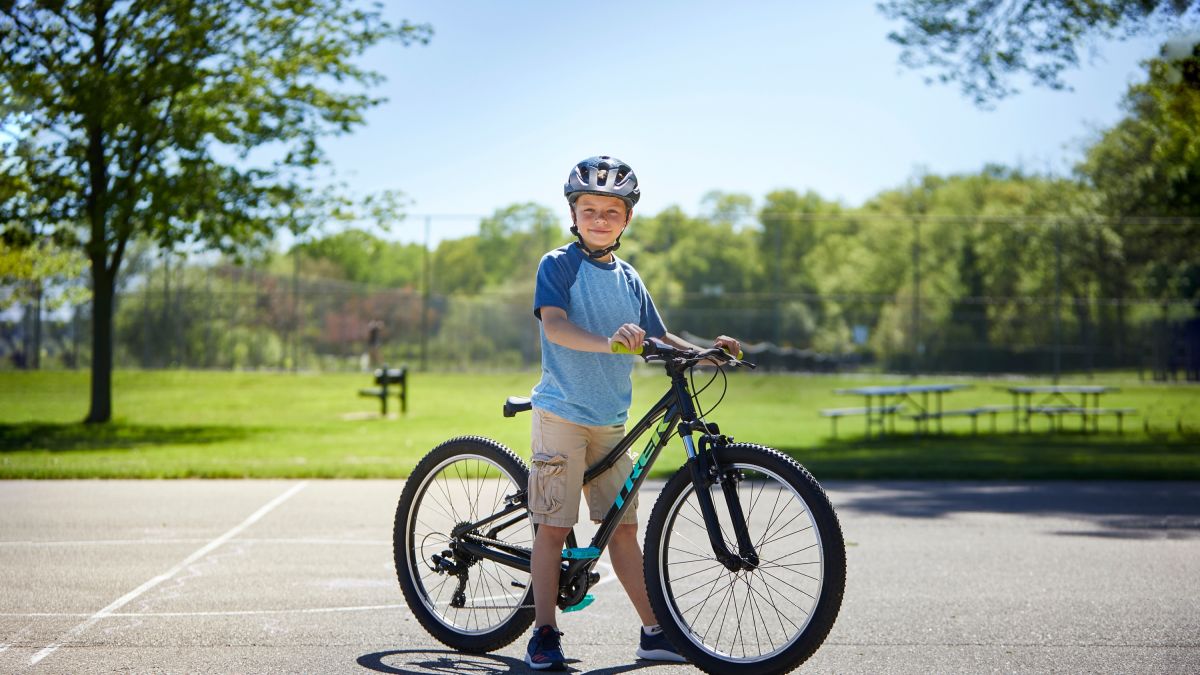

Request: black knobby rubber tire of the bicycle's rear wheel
left=392, top=436, right=534, bottom=653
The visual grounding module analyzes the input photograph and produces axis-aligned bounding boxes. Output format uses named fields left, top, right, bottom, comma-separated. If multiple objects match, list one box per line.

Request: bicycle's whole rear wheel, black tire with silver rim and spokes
left=392, top=436, right=534, bottom=653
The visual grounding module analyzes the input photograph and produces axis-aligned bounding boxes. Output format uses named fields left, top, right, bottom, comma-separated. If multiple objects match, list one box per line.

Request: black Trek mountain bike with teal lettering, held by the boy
left=392, top=340, right=846, bottom=673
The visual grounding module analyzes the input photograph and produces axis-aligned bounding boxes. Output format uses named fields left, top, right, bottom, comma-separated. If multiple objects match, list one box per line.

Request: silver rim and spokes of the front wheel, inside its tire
left=658, top=464, right=826, bottom=663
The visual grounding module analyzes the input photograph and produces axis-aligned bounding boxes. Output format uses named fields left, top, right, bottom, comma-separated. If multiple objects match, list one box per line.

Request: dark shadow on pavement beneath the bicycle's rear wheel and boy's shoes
left=358, top=650, right=680, bottom=675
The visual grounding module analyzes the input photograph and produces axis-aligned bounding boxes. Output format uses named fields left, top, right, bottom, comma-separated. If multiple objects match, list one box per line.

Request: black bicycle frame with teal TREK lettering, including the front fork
left=451, top=362, right=758, bottom=597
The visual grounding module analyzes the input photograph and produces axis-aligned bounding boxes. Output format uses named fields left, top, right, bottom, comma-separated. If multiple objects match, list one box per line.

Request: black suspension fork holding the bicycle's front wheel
left=679, top=422, right=758, bottom=572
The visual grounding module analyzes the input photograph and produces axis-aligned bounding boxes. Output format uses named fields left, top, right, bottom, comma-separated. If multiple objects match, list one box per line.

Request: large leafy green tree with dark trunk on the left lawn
left=0, top=0, right=431, bottom=423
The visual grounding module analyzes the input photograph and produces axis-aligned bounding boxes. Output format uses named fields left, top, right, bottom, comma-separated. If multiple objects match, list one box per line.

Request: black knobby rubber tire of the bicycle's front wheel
left=644, top=443, right=846, bottom=675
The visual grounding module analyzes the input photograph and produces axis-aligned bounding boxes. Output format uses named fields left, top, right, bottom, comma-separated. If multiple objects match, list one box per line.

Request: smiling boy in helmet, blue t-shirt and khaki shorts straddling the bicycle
left=526, top=156, right=740, bottom=670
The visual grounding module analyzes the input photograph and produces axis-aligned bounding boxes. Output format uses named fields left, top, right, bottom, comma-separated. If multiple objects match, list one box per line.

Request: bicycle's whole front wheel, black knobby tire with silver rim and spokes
left=646, top=443, right=846, bottom=674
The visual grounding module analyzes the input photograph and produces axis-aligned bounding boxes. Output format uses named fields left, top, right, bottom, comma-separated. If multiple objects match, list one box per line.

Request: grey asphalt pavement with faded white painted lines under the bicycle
left=0, top=480, right=1200, bottom=675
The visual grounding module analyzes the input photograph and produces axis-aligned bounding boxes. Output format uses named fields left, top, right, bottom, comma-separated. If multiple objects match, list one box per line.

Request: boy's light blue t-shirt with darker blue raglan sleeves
left=532, top=244, right=667, bottom=426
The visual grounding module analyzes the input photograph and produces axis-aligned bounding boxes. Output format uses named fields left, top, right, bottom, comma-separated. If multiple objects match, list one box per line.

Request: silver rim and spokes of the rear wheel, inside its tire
left=404, top=454, right=533, bottom=634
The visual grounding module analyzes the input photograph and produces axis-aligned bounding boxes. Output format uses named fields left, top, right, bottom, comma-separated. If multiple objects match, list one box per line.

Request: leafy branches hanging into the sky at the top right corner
left=878, top=0, right=1198, bottom=107
